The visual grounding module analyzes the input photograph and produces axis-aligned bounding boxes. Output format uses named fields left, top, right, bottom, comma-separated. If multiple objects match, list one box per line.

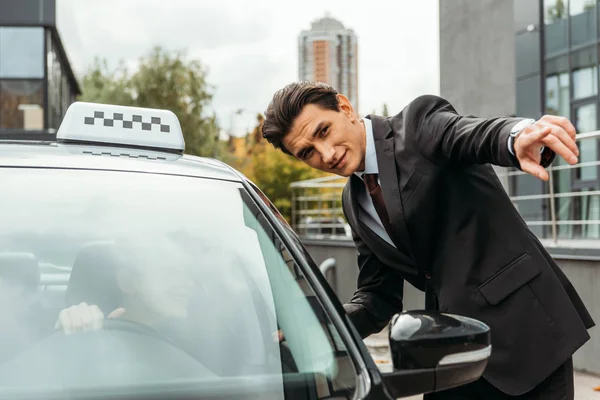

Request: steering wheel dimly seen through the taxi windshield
left=0, top=319, right=214, bottom=387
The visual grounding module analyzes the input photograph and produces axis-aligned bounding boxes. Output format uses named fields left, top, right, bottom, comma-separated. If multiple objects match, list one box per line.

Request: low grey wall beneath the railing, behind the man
left=304, top=241, right=600, bottom=374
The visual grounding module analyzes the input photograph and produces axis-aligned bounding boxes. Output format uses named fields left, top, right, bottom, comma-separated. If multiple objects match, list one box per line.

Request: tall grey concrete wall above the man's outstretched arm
left=439, top=0, right=516, bottom=117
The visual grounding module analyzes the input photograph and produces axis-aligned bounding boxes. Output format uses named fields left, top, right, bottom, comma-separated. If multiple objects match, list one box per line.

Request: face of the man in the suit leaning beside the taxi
left=283, top=95, right=366, bottom=176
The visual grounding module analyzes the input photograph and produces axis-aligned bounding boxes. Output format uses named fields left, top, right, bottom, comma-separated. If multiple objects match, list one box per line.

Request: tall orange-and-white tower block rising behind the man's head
left=298, top=15, right=358, bottom=111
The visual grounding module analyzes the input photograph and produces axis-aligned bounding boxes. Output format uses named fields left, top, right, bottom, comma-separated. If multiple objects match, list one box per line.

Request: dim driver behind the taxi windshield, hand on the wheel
left=55, top=237, right=295, bottom=376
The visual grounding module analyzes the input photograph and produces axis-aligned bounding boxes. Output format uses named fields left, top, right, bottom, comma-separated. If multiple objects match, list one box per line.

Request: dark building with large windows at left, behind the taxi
left=0, top=0, right=80, bottom=135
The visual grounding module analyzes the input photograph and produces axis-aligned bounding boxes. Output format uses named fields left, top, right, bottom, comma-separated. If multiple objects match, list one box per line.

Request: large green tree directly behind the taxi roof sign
left=80, top=47, right=220, bottom=156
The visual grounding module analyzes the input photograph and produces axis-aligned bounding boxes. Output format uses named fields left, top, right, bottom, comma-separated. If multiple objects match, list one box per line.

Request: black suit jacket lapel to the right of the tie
left=369, top=116, right=412, bottom=260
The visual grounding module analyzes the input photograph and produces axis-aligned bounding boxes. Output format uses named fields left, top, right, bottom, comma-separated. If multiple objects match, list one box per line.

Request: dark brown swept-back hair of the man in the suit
left=262, top=81, right=340, bottom=155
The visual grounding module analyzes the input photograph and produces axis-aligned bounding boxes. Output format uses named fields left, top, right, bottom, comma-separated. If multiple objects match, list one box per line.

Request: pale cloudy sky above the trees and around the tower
left=57, top=0, right=439, bottom=136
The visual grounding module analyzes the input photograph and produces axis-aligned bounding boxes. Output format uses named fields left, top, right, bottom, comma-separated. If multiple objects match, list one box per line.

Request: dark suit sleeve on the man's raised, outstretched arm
left=406, top=95, right=554, bottom=168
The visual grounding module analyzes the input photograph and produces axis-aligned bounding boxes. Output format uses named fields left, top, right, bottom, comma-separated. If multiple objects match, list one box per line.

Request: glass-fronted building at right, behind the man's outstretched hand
left=509, top=0, right=600, bottom=240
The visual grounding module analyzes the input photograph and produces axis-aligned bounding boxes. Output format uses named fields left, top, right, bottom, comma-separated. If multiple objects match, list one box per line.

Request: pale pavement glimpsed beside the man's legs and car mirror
left=364, top=329, right=600, bottom=400
